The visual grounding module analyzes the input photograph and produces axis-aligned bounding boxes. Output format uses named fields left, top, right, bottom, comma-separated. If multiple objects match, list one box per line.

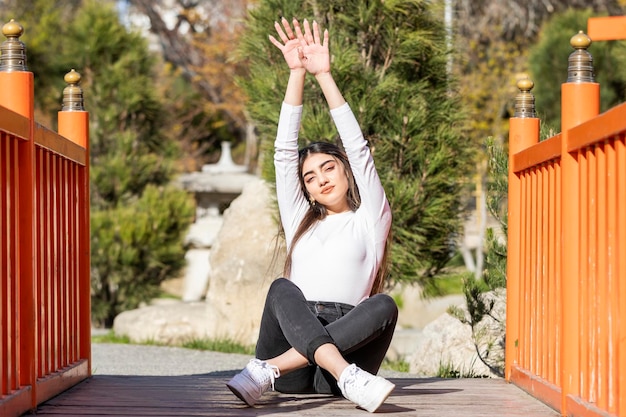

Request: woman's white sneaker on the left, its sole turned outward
left=226, top=359, right=280, bottom=406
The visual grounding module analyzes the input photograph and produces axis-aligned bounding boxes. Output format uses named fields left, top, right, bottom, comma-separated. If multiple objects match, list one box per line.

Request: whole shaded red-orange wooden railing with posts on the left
left=0, top=21, right=91, bottom=416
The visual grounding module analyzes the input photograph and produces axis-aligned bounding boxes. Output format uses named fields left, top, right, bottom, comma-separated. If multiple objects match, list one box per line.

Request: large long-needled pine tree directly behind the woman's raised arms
left=240, top=0, right=476, bottom=285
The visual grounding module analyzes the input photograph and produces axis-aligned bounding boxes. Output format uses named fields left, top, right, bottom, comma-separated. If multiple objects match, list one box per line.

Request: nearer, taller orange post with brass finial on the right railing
left=561, top=31, right=600, bottom=412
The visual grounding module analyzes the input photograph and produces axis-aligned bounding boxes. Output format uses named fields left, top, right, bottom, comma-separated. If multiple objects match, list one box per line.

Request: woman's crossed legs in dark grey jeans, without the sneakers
left=256, top=278, right=398, bottom=394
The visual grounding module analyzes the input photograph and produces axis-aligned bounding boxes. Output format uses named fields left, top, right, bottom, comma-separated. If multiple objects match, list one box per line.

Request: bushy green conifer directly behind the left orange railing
left=1, top=0, right=193, bottom=326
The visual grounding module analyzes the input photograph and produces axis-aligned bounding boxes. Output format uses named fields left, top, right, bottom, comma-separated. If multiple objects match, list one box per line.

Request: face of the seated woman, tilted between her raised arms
left=302, top=153, right=350, bottom=214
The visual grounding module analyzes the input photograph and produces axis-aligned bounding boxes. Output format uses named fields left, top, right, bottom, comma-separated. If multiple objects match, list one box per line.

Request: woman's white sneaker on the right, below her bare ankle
left=339, top=364, right=395, bottom=413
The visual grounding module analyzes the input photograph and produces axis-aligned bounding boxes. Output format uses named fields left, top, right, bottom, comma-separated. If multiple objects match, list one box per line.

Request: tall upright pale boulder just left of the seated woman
left=206, top=180, right=285, bottom=344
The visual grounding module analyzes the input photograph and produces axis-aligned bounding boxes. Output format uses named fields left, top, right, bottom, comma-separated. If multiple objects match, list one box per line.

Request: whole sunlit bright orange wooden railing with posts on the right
left=505, top=17, right=626, bottom=416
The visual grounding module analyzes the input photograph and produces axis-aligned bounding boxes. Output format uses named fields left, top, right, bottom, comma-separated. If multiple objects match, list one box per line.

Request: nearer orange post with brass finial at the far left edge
left=0, top=19, right=37, bottom=408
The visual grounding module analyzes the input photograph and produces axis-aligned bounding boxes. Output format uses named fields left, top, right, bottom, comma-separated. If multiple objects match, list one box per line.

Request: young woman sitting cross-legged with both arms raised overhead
left=227, top=18, right=398, bottom=412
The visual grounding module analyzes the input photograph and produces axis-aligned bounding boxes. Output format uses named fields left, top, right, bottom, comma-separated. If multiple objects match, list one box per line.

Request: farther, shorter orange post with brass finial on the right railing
left=504, top=78, right=539, bottom=381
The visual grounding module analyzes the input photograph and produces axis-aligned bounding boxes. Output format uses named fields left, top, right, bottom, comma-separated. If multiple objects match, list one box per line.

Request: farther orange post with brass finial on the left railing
left=57, top=69, right=91, bottom=375
